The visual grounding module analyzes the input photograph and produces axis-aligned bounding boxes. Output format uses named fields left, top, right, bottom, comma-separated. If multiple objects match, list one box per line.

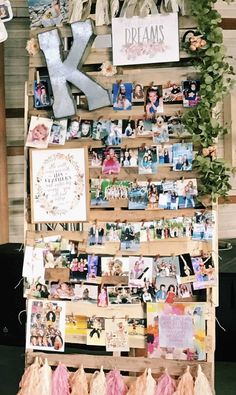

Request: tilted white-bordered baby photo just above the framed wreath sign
left=25, top=116, right=53, bottom=149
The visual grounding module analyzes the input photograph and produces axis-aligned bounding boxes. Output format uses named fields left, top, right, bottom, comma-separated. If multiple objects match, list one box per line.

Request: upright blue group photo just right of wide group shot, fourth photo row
left=128, top=181, right=148, bottom=210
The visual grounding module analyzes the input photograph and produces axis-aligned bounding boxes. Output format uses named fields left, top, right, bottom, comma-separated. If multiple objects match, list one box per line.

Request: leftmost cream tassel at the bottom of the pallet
left=17, top=358, right=40, bottom=395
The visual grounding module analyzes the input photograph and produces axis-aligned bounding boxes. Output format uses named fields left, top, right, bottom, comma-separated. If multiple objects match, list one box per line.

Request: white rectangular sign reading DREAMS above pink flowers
left=112, top=12, right=179, bottom=65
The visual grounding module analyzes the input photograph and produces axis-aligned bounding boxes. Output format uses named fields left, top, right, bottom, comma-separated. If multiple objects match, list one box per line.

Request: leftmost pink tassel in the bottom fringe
left=51, top=363, right=70, bottom=395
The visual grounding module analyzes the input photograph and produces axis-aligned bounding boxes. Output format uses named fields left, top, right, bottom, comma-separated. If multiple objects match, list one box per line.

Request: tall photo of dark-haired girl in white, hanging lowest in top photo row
left=144, top=85, right=163, bottom=119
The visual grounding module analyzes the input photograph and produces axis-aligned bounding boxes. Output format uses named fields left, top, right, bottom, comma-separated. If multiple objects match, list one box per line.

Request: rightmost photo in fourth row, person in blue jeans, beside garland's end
left=177, top=178, right=198, bottom=208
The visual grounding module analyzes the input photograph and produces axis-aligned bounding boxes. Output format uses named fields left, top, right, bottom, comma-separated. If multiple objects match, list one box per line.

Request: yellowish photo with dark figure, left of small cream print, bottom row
left=87, top=316, right=106, bottom=346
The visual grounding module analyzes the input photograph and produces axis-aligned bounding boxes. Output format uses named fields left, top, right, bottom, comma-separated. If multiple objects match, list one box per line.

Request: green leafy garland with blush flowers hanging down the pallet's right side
left=183, top=0, right=234, bottom=201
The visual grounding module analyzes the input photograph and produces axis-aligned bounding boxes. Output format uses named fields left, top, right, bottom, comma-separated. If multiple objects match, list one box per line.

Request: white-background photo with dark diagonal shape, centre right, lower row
left=129, top=255, right=153, bottom=288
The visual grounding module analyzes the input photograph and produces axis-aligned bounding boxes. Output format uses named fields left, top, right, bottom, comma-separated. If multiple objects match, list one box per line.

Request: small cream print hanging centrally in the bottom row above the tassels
left=105, top=318, right=129, bottom=352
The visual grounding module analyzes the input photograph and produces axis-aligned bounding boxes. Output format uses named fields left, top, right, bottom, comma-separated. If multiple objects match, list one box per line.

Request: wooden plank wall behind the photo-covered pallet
left=4, top=0, right=236, bottom=243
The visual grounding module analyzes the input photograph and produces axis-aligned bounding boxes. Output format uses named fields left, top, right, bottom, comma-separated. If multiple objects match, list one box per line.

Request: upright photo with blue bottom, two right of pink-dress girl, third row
left=138, top=146, right=157, bottom=174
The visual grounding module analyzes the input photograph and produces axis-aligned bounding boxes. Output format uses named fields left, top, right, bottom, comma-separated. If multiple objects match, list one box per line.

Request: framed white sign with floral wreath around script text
left=30, top=148, right=87, bottom=223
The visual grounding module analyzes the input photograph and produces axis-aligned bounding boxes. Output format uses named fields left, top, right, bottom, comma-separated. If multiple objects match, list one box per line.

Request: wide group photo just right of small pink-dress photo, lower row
left=107, top=286, right=141, bottom=305
